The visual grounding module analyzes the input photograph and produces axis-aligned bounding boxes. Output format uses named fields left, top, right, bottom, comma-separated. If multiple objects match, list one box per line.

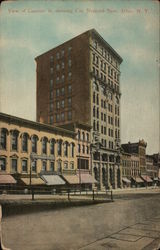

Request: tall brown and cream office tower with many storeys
left=35, top=29, right=122, bottom=189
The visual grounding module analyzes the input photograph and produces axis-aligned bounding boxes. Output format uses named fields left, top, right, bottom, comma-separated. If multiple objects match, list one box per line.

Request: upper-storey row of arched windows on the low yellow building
left=0, top=128, right=75, bottom=157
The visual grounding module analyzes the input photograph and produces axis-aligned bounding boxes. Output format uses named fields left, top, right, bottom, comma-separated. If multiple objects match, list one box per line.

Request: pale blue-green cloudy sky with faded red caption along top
left=0, top=0, right=160, bottom=154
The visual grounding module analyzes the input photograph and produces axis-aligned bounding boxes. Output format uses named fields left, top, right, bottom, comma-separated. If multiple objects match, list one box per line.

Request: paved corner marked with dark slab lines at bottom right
left=79, top=217, right=160, bottom=250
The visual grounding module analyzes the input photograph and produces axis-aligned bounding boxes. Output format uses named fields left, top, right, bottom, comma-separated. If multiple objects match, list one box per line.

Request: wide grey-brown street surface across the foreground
left=2, top=193, right=160, bottom=250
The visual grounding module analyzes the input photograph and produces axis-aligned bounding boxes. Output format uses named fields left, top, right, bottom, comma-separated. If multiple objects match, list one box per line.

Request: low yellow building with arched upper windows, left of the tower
left=0, top=113, right=94, bottom=186
